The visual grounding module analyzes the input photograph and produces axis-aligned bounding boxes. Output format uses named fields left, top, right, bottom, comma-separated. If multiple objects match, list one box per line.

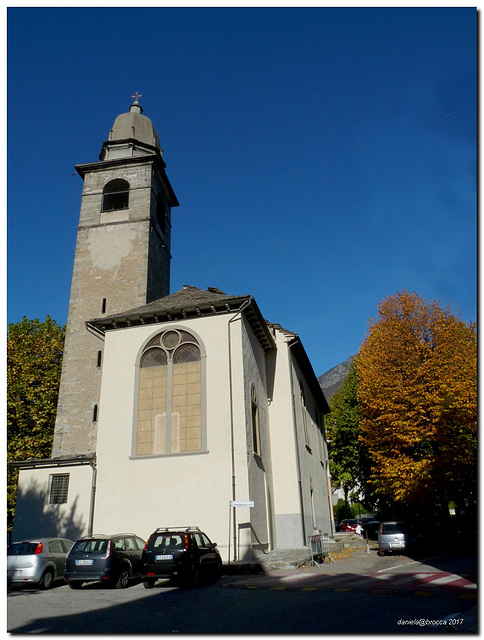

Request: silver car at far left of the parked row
left=7, top=538, right=73, bottom=589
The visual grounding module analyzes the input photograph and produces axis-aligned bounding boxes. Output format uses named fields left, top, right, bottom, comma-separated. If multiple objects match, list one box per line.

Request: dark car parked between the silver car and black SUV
left=64, top=533, right=145, bottom=589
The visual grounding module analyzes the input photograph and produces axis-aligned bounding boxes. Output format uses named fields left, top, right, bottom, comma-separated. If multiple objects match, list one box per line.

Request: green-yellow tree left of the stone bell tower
left=7, top=316, right=65, bottom=529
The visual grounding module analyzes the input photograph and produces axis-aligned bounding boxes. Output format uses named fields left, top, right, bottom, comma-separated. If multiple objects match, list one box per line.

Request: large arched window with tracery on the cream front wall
left=135, top=329, right=204, bottom=456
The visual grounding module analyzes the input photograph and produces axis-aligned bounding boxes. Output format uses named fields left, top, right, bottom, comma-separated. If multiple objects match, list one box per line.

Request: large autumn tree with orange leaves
left=356, top=291, right=477, bottom=508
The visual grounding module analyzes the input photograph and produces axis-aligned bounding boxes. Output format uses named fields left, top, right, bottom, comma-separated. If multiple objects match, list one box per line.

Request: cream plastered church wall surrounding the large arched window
left=94, top=314, right=255, bottom=561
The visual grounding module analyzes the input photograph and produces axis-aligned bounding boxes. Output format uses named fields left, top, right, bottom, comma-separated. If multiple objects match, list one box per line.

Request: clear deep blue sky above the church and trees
left=7, top=7, right=477, bottom=375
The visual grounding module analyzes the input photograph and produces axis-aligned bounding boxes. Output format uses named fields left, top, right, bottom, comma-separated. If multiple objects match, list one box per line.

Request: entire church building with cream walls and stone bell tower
left=13, top=94, right=333, bottom=562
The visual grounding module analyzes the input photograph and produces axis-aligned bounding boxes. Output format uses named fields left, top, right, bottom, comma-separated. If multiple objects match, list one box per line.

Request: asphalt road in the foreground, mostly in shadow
left=7, top=554, right=476, bottom=634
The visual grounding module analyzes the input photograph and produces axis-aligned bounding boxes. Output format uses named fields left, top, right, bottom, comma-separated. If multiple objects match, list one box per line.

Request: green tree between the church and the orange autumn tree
left=324, top=362, right=371, bottom=504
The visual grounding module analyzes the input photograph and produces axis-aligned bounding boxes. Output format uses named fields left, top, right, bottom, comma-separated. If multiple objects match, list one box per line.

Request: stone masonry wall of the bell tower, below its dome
left=52, top=162, right=169, bottom=457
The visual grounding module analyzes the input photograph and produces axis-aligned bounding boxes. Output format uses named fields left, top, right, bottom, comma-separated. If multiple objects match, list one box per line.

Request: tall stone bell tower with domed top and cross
left=52, top=92, right=178, bottom=458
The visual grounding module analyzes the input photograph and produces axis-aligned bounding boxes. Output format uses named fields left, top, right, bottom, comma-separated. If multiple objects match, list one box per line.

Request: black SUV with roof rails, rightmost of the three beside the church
left=143, top=527, right=222, bottom=589
